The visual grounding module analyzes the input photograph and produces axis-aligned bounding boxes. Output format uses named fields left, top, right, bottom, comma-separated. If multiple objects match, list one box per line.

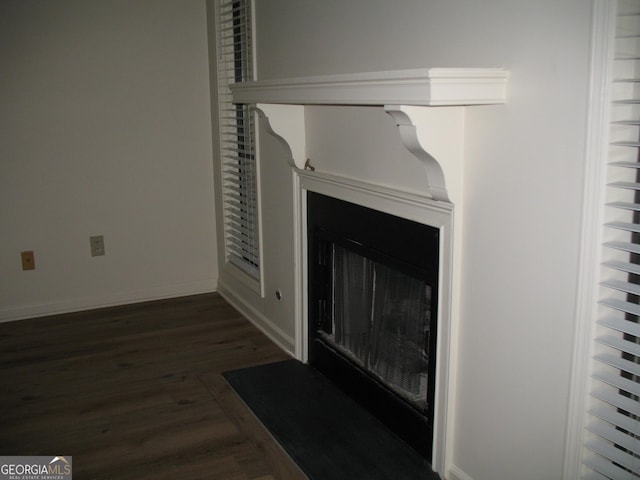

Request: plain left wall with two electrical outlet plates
left=0, top=0, right=217, bottom=320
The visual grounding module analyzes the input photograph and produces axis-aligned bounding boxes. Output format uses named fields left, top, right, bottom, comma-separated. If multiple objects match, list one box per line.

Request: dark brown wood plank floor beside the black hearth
left=0, top=294, right=306, bottom=480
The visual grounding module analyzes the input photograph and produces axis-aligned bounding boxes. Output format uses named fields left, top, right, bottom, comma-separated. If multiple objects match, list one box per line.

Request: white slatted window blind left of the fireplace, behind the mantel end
left=216, top=0, right=260, bottom=278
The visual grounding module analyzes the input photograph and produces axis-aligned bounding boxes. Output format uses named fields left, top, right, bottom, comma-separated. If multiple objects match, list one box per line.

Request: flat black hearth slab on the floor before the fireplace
left=223, top=360, right=440, bottom=480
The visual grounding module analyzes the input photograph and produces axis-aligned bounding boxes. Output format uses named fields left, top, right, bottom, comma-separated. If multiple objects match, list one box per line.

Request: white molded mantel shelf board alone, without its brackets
left=231, top=68, right=508, bottom=106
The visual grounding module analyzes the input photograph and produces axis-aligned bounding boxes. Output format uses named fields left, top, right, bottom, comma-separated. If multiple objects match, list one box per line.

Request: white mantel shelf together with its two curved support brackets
left=231, top=68, right=508, bottom=203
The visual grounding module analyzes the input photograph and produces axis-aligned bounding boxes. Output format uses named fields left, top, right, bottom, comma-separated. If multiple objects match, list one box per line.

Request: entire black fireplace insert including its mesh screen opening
left=307, top=192, right=440, bottom=461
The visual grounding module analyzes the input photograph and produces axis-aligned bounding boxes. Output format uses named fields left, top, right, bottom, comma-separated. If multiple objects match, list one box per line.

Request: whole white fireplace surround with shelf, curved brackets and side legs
left=231, top=68, right=508, bottom=480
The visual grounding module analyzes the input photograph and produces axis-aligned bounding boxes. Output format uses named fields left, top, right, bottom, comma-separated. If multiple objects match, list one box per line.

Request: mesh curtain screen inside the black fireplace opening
left=330, top=244, right=432, bottom=408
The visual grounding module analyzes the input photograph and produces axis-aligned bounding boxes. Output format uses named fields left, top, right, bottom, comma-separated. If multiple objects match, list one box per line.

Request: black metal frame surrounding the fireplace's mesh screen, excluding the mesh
left=307, top=192, right=440, bottom=461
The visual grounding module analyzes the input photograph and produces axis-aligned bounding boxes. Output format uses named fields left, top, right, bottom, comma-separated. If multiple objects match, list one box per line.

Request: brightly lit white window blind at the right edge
left=583, top=0, right=640, bottom=480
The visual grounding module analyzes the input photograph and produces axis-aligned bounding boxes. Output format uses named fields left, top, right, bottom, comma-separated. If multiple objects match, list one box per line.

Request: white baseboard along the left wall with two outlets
left=0, top=278, right=218, bottom=323
